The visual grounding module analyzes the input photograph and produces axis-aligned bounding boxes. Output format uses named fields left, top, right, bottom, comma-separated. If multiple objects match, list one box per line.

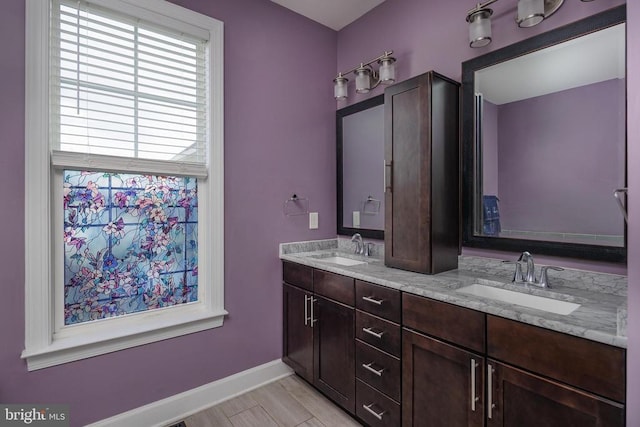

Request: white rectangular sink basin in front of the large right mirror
left=457, top=283, right=580, bottom=315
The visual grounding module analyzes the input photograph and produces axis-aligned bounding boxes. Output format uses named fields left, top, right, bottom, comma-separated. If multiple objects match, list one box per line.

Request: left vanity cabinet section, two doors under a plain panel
left=282, top=262, right=355, bottom=414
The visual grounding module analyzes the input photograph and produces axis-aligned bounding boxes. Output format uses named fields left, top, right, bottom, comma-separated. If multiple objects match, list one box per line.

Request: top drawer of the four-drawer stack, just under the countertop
left=356, top=280, right=401, bottom=323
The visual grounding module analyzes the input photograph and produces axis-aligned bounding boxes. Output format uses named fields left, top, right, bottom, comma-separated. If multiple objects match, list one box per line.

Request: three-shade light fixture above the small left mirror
left=333, top=51, right=396, bottom=99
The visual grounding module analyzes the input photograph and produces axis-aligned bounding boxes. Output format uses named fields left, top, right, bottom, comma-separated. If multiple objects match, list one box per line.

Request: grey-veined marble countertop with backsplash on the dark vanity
left=280, top=239, right=627, bottom=348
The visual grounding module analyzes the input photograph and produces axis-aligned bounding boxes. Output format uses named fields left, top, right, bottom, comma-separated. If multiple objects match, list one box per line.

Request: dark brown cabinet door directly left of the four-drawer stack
left=313, top=296, right=356, bottom=414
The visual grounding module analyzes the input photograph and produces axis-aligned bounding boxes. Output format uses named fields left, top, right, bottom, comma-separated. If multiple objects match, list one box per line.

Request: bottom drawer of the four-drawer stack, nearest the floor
left=356, top=380, right=400, bottom=427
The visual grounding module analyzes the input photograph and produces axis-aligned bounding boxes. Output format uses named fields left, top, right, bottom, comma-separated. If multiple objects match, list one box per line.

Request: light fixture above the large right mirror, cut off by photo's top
left=467, top=0, right=564, bottom=47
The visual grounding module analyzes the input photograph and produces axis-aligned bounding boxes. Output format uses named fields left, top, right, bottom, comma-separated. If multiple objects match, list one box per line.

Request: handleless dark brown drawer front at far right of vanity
left=487, top=316, right=625, bottom=402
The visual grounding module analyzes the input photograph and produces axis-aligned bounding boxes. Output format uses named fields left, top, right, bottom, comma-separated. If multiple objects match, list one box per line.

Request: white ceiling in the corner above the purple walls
left=271, top=0, right=384, bottom=31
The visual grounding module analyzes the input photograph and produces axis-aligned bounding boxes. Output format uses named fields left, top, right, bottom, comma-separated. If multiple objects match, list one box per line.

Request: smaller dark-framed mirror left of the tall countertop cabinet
left=336, top=95, right=384, bottom=239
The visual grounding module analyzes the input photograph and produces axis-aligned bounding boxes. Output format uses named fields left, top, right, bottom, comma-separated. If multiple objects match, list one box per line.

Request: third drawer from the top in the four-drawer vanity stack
left=356, top=341, right=401, bottom=402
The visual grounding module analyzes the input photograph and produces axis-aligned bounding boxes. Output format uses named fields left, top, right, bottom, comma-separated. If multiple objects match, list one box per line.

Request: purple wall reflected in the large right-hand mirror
left=498, top=79, right=626, bottom=236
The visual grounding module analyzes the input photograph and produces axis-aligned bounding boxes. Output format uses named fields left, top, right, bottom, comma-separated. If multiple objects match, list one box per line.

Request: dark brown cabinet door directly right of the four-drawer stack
left=402, top=329, right=482, bottom=427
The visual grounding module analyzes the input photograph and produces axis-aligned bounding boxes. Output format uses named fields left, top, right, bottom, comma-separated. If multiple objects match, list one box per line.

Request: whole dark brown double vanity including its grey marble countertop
left=280, top=239, right=627, bottom=427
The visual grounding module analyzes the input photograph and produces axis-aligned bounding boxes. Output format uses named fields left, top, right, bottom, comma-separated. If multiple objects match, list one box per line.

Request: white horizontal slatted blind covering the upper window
left=50, top=0, right=207, bottom=171
